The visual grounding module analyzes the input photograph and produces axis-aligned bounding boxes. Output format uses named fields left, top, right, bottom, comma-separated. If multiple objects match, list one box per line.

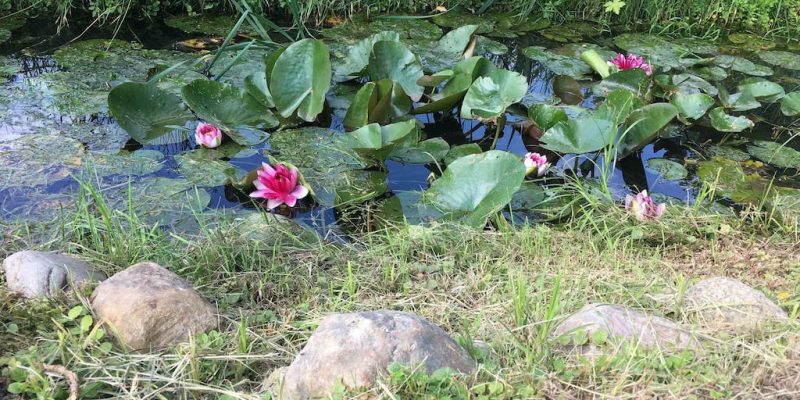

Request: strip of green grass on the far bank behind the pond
left=0, top=0, right=800, bottom=37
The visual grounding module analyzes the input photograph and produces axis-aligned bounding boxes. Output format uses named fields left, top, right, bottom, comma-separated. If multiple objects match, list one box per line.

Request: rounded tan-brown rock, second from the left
left=91, top=262, right=217, bottom=349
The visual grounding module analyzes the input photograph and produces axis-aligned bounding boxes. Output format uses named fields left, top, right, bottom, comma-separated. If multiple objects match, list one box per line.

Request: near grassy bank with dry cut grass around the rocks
left=0, top=180, right=800, bottom=399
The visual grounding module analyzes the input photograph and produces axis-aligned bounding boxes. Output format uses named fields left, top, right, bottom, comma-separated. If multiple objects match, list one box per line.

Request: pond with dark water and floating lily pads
left=0, top=14, right=800, bottom=234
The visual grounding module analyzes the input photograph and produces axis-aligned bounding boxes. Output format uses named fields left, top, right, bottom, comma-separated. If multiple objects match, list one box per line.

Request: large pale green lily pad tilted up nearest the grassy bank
left=422, top=150, right=525, bottom=228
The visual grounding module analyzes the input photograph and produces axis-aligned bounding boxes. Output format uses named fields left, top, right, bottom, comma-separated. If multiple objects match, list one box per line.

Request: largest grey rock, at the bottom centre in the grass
left=282, top=311, right=475, bottom=400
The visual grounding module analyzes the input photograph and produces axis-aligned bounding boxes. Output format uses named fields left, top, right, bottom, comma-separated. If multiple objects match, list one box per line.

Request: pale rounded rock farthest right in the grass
left=683, top=277, right=789, bottom=334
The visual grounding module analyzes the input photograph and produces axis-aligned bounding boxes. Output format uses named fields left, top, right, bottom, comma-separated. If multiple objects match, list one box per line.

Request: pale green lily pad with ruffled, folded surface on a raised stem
left=461, top=69, right=528, bottom=119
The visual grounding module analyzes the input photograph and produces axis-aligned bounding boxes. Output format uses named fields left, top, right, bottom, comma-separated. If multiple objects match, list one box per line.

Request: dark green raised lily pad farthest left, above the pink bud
left=108, top=82, right=192, bottom=144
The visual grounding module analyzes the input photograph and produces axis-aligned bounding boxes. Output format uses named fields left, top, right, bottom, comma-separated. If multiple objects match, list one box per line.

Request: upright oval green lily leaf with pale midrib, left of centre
left=269, top=39, right=332, bottom=122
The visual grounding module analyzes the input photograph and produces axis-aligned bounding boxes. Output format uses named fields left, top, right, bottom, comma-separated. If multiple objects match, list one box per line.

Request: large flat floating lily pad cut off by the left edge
left=0, top=134, right=84, bottom=188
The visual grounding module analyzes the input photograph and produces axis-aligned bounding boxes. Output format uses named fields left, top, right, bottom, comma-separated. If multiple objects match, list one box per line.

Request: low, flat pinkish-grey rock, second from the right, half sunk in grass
left=553, top=304, right=698, bottom=357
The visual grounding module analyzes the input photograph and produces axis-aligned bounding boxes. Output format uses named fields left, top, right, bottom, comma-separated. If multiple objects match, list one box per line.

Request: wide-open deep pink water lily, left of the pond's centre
left=250, top=163, right=308, bottom=210
